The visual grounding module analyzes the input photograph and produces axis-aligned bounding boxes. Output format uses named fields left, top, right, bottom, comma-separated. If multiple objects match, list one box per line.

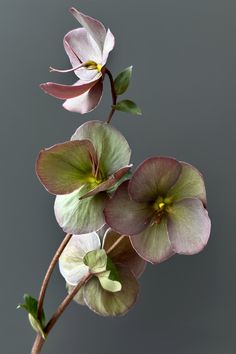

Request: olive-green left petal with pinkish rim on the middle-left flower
left=36, top=140, right=97, bottom=194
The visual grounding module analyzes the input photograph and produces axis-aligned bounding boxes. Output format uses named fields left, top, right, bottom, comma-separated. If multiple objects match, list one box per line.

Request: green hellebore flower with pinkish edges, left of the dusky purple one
left=36, top=121, right=131, bottom=234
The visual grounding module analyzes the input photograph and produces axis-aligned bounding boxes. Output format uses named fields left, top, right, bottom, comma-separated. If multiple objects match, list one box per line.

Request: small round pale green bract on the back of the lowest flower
left=83, top=249, right=107, bottom=274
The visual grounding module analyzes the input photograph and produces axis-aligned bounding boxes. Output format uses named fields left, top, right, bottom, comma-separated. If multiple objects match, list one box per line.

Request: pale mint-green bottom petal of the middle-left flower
left=54, top=187, right=107, bottom=234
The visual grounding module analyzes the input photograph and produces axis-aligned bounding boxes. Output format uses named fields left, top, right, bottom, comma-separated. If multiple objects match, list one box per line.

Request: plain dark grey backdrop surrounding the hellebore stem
left=0, top=0, right=236, bottom=354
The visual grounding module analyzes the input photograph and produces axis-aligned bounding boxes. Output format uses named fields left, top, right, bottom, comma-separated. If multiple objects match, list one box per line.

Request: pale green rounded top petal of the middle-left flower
left=71, top=121, right=131, bottom=178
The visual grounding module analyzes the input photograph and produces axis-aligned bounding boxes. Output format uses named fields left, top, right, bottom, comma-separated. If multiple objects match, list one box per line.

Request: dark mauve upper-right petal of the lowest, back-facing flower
left=102, top=229, right=146, bottom=277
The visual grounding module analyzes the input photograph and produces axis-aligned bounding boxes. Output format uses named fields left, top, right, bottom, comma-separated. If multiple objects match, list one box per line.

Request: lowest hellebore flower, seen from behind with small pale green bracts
left=59, top=229, right=146, bottom=316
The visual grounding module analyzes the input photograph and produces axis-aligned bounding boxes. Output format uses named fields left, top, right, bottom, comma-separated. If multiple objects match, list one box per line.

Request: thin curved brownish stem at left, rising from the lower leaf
left=38, top=234, right=72, bottom=320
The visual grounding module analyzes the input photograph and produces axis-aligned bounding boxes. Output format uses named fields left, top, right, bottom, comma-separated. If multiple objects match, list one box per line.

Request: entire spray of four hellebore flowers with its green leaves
left=22, top=8, right=211, bottom=346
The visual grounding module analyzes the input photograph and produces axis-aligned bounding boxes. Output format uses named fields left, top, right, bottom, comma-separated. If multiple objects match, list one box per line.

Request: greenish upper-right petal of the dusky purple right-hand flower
left=167, top=162, right=206, bottom=206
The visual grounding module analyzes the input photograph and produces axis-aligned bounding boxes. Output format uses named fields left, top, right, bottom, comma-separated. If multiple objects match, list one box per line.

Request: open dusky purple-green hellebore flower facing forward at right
left=104, top=157, right=211, bottom=263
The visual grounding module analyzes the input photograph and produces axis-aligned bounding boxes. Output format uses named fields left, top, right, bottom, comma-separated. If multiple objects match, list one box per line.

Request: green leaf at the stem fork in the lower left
left=17, top=294, right=46, bottom=339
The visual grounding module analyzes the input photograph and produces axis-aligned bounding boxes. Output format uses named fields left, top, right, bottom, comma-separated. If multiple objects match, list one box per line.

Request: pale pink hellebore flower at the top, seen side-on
left=41, top=8, right=115, bottom=114
